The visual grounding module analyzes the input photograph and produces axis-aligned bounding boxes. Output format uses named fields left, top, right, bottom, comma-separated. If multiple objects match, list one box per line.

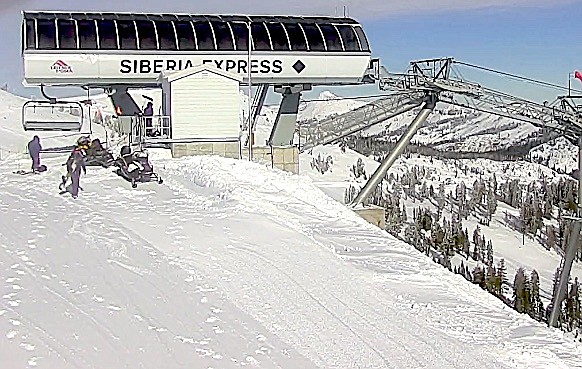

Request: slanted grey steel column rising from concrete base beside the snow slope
left=351, top=94, right=437, bottom=206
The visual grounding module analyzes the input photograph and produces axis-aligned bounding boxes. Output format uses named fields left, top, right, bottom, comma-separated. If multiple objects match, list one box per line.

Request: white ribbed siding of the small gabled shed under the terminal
left=171, top=72, right=240, bottom=139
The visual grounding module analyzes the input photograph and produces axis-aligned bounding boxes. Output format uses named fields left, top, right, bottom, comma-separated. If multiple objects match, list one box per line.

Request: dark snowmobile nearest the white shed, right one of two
left=115, top=146, right=164, bottom=188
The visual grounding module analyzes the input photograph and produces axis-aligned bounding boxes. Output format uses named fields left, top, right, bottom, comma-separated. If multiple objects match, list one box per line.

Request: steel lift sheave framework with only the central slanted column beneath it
left=299, top=58, right=582, bottom=201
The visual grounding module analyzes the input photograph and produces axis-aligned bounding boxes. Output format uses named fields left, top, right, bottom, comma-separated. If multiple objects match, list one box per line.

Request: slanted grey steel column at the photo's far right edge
left=548, top=136, right=582, bottom=327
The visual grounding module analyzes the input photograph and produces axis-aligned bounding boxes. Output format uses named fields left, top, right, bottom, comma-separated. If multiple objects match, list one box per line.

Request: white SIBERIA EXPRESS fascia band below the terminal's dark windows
left=24, top=53, right=370, bottom=86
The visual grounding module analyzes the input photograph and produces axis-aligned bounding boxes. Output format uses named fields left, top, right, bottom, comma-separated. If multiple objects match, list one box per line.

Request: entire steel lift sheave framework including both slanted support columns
left=300, top=58, right=582, bottom=327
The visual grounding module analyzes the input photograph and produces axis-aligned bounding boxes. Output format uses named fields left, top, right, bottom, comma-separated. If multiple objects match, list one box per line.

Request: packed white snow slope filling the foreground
left=0, top=148, right=582, bottom=369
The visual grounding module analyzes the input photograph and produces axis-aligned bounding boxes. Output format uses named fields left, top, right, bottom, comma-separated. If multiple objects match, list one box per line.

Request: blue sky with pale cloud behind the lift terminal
left=0, top=0, right=582, bottom=101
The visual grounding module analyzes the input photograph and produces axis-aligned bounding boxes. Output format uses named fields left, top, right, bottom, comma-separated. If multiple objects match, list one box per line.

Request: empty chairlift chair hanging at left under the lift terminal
left=22, top=99, right=83, bottom=132
